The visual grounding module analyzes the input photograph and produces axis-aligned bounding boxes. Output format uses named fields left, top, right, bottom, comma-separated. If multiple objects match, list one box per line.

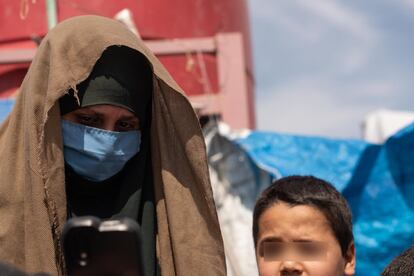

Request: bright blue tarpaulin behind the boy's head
left=236, top=128, right=414, bottom=276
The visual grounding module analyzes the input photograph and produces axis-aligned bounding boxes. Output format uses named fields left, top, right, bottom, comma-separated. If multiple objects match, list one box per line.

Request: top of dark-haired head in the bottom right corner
left=381, top=246, right=414, bottom=276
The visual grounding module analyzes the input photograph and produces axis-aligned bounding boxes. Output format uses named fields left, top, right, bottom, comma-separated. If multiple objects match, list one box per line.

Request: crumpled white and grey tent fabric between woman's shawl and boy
left=203, top=122, right=270, bottom=276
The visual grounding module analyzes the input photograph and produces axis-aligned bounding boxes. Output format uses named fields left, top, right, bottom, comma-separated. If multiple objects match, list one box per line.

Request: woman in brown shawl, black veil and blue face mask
left=0, top=16, right=225, bottom=275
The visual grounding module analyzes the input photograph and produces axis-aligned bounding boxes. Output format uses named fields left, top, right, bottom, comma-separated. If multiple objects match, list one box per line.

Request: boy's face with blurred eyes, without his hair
left=256, top=203, right=355, bottom=276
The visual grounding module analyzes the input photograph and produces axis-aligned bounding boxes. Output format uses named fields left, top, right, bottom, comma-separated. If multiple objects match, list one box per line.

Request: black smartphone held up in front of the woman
left=62, top=216, right=144, bottom=276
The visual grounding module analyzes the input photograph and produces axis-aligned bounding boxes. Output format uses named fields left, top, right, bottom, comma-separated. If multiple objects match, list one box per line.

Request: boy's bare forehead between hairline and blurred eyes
left=258, top=202, right=334, bottom=241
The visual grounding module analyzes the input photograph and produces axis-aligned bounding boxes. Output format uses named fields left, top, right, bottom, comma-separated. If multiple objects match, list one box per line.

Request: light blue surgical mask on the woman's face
left=62, top=120, right=141, bottom=182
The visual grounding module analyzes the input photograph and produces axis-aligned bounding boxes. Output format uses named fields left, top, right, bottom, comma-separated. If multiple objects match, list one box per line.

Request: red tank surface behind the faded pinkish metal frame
left=0, top=0, right=254, bottom=127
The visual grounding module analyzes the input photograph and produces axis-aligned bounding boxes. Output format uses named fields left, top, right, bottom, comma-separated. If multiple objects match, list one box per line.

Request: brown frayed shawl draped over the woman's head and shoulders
left=0, top=16, right=226, bottom=276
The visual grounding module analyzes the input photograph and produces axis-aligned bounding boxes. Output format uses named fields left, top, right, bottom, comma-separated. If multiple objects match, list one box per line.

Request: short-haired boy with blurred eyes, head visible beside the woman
left=253, top=176, right=355, bottom=276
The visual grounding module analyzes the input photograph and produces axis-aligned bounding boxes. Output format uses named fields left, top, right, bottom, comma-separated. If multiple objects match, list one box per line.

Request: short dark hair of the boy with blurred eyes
left=253, top=176, right=354, bottom=257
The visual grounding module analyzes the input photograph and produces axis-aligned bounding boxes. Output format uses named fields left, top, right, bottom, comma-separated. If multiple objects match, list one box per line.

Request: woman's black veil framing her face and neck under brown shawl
left=60, top=46, right=159, bottom=276
